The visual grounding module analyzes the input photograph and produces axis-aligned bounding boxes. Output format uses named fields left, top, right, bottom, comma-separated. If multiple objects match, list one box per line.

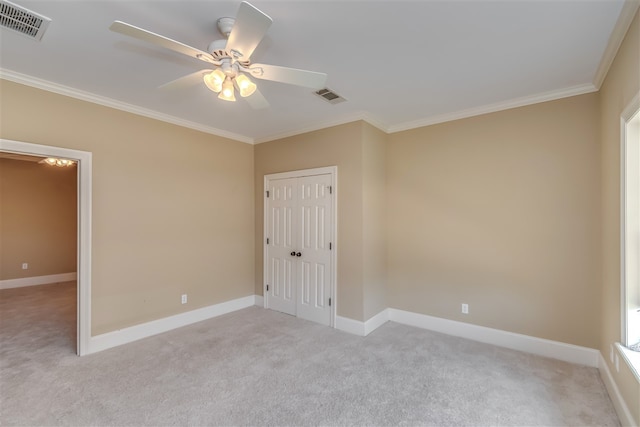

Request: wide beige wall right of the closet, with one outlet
left=387, top=94, right=600, bottom=348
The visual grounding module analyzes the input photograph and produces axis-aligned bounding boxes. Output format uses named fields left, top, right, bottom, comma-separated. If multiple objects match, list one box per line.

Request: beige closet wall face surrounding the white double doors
left=254, top=122, right=363, bottom=320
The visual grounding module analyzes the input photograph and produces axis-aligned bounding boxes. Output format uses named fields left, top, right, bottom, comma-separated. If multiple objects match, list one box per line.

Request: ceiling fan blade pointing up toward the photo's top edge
left=227, top=1, right=273, bottom=61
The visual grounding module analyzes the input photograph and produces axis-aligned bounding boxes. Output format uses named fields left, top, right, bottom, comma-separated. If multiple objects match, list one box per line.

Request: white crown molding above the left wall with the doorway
left=0, top=68, right=253, bottom=144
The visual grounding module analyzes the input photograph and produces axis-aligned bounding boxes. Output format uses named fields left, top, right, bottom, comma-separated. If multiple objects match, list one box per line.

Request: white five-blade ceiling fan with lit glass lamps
left=109, top=1, right=327, bottom=108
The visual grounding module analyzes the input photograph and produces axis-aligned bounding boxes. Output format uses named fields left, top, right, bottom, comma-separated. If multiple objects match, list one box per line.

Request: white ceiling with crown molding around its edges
left=0, top=0, right=637, bottom=143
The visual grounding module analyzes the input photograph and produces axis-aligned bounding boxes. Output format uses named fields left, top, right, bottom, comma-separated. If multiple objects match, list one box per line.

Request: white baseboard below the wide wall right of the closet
left=388, top=308, right=600, bottom=368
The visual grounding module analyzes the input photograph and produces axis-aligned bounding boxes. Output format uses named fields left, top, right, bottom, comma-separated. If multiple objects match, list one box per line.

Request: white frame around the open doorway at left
left=0, top=139, right=92, bottom=356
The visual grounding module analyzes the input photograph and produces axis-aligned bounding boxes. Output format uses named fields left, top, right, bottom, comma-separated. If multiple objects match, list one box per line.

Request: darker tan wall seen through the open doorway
left=0, top=159, right=77, bottom=280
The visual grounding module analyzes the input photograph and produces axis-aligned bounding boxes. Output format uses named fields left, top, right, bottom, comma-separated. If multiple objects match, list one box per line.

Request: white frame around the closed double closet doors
left=262, top=166, right=339, bottom=328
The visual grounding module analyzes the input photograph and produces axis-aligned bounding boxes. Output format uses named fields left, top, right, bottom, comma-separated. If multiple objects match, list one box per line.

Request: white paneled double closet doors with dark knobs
left=265, top=174, right=334, bottom=325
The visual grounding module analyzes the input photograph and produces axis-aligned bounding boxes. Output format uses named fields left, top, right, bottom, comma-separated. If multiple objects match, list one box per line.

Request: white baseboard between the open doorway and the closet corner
left=88, top=295, right=256, bottom=354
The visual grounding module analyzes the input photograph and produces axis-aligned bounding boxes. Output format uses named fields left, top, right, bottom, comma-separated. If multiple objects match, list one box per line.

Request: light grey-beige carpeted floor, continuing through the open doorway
left=0, top=283, right=619, bottom=426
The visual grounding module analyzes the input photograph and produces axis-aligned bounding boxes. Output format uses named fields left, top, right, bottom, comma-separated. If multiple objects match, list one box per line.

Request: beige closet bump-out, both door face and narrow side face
left=255, top=122, right=387, bottom=321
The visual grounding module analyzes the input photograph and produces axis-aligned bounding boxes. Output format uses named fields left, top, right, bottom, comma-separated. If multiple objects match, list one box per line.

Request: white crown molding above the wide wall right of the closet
left=387, top=83, right=598, bottom=133
